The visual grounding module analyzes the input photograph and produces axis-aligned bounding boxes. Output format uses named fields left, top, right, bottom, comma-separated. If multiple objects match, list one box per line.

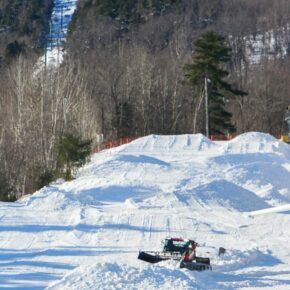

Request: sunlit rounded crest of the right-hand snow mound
left=224, top=132, right=290, bottom=158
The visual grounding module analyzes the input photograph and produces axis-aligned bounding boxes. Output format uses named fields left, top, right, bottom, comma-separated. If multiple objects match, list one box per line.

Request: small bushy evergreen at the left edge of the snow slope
left=57, top=134, right=92, bottom=180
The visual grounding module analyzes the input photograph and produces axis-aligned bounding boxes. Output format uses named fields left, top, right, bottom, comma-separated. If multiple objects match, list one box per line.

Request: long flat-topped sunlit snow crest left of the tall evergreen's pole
left=119, top=134, right=218, bottom=153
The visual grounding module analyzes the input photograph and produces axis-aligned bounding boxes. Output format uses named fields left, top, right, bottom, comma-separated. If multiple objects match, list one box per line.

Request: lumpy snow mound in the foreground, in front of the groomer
left=47, top=263, right=201, bottom=290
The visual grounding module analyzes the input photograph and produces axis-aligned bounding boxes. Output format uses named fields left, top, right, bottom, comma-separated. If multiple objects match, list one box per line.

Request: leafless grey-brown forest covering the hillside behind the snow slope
left=0, top=0, right=290, bottom=198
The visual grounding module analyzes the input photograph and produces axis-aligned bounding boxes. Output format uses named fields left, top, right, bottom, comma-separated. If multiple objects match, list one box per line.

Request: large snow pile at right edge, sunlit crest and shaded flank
left=213, top=132, right=290, bottom=205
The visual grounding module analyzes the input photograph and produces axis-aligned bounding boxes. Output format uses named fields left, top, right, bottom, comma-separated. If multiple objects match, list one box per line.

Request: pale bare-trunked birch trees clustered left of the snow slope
left=0, top=57, right=99, bottom=198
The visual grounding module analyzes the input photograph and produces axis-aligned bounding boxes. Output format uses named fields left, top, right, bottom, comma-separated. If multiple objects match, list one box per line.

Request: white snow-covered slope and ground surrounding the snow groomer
left=0, top=133, right=290, bottom=290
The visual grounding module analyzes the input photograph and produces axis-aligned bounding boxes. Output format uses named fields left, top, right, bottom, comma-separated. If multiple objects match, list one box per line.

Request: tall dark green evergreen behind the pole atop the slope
left=186, top=31, right=246, bottom=134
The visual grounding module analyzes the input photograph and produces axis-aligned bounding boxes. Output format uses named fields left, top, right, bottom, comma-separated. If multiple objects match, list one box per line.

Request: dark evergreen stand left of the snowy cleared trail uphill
left=0, top=0, right=53, bottom=67
